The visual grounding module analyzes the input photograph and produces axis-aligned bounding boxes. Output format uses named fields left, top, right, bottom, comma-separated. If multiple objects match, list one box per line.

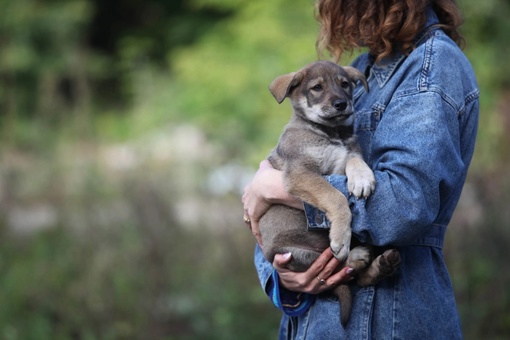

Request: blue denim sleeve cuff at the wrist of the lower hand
left=255, top=245, right=315, bottom=316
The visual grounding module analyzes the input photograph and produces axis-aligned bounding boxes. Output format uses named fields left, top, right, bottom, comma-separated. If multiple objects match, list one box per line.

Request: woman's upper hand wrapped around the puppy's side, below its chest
left=242, top=160, right=303, bottom=247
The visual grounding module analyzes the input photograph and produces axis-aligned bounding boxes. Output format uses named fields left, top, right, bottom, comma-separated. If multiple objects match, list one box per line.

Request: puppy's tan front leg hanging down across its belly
left=284, top=167, right=351, bottom=261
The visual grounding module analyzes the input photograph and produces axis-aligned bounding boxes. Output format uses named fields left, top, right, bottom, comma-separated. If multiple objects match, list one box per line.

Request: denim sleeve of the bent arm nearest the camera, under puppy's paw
left=305, top=92, right=471, bottom=246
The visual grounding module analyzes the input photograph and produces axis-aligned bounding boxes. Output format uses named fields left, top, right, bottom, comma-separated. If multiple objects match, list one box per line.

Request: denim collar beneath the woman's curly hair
left=369, top=6, right=439, bottom=87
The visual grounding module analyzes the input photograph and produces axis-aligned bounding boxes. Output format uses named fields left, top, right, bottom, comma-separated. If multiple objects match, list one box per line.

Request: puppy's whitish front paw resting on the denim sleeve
left=345, top=155, right=375, bottom=198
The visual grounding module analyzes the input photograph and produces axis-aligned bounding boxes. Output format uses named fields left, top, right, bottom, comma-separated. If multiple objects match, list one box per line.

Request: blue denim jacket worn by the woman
left=255, top=10, right=479, bottom=340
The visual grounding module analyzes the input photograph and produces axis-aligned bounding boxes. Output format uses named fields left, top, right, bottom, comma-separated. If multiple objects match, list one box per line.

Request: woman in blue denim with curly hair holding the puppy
left=243, top=0, right=479, bottom=339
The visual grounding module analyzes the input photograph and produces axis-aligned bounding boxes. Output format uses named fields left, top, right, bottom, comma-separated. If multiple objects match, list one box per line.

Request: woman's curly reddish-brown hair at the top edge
left=316, top=0, right=464, bottom=61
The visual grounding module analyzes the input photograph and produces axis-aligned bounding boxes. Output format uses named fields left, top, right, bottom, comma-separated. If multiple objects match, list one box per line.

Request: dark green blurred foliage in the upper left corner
left=0, top=0, right=235, bottom=143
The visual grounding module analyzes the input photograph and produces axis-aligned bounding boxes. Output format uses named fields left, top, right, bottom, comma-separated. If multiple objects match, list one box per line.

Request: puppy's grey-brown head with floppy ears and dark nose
left=269, top=61, right=368, bottom=127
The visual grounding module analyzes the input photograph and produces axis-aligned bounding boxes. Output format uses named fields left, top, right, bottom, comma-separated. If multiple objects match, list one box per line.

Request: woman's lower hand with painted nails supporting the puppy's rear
left=273, top=248, right=353, bottom=294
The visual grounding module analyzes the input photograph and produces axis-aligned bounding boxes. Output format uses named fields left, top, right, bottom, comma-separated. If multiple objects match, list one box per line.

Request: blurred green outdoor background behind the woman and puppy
left=0, top=0, right=510, bottom=340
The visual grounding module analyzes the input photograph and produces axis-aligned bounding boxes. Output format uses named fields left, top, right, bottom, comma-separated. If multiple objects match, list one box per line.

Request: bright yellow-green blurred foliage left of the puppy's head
left=170, top=0, right=318, bottom=159
